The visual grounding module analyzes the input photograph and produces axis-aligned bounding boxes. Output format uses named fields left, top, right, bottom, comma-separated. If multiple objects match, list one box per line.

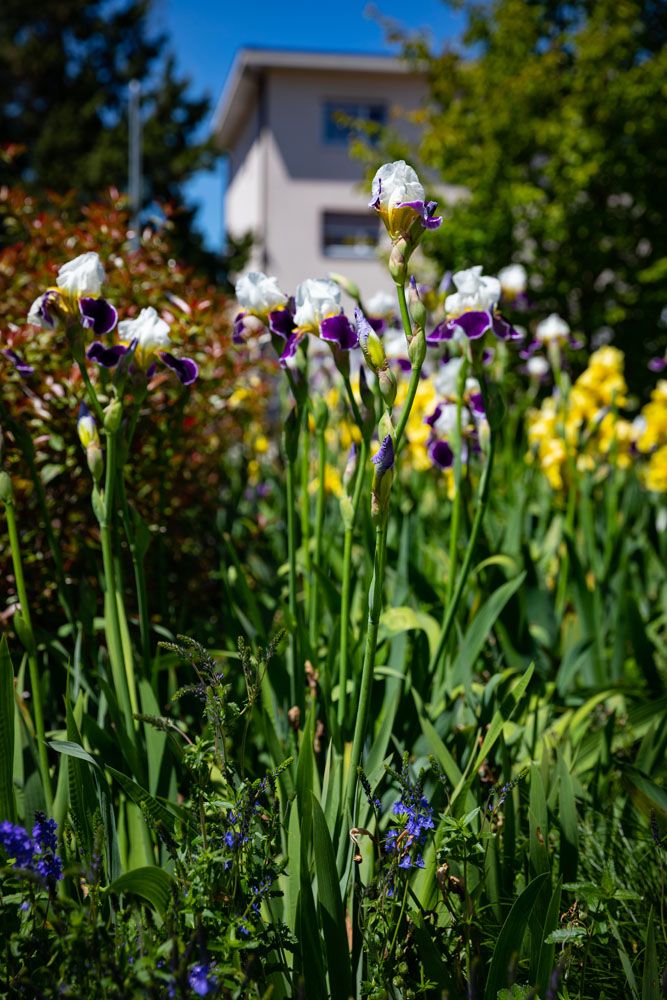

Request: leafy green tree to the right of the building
left=380, top=0, right=667, bottom=378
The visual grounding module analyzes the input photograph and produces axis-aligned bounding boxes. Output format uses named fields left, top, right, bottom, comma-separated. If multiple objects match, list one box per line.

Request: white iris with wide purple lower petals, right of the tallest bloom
left=426, top=264, right=521, bottom=344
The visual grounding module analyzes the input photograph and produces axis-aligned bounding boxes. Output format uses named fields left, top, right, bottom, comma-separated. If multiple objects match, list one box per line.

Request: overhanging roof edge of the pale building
left=211, top=47, right=414, bottom=149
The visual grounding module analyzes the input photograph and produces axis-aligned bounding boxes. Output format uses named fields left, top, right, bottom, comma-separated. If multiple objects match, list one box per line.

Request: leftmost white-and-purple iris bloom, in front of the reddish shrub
left=28, top=251, right=118, bottom=336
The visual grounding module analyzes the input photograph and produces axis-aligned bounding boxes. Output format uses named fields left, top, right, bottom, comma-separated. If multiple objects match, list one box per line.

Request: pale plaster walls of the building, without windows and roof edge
left=225, top=68, right=426, bottom=297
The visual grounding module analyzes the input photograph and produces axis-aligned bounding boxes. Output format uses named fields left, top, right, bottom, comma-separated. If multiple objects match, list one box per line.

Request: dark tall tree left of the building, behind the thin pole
left=0, top=0, right=224, bottom=267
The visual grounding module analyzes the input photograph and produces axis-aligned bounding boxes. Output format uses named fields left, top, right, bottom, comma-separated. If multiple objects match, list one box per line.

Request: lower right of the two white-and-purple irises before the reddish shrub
left=86, top=306, right=199, bottom=385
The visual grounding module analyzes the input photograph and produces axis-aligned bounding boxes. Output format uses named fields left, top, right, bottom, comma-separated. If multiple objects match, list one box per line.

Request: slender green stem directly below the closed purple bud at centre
left=339, top=510, right=388, bottom=844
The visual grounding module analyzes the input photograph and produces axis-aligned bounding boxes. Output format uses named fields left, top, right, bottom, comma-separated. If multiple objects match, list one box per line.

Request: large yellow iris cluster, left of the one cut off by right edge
left=527, top=347, right=635, bottom=490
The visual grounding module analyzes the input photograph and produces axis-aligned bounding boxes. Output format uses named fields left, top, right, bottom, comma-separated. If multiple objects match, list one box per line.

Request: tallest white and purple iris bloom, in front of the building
left=369, top=160, right=442, bottom=242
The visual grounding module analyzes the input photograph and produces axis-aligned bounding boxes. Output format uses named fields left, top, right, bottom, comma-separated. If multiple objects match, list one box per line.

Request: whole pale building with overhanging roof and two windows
left=214, top=49, right=434, bottom=296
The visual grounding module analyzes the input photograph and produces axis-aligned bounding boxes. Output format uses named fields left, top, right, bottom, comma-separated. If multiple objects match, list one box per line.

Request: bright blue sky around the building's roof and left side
left=154, top=0, right=461, bottom=249
